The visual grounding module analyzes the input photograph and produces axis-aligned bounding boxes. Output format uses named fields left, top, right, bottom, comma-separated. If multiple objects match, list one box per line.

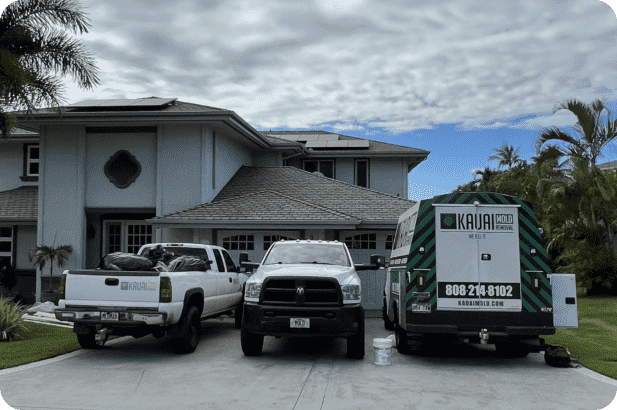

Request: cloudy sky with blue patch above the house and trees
left=6, top=0, right=617, bottom=199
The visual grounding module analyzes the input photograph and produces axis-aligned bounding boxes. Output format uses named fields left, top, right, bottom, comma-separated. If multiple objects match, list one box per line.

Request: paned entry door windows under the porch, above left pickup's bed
left=105, top=221, right=152, bottom=253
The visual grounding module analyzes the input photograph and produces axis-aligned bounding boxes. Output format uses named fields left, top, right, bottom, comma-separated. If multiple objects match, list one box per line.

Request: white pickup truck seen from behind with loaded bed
left=55, top=243, right=248, bottom=353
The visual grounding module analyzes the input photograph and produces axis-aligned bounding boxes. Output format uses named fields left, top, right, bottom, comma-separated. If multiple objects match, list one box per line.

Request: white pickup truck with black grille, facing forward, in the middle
left=240, top=239, right=384, bottom=359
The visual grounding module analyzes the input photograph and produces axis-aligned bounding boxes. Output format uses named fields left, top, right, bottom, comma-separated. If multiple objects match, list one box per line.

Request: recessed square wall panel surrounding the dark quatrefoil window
left=86, top=133, right=156, bottom=208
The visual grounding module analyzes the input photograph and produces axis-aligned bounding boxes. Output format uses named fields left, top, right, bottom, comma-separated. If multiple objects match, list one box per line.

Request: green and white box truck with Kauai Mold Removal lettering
left=383, top=192, right=578, bottom=358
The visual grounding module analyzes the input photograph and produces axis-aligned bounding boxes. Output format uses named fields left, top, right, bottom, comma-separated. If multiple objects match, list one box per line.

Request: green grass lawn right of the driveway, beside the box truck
left=542, top=297, right=617, bottom=379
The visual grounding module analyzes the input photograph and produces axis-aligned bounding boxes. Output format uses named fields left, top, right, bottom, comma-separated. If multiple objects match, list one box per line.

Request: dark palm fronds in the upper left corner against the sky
left=0, top=0, right=99, bottom=137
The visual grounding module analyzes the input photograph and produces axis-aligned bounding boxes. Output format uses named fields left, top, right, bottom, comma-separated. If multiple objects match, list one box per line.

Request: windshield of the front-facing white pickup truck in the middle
left=263, top=243, right=350, bottom=266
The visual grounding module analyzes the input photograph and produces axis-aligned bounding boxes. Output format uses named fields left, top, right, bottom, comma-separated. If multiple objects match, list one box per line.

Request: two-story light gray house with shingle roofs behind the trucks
left=6, top=97, right=429, bottom=308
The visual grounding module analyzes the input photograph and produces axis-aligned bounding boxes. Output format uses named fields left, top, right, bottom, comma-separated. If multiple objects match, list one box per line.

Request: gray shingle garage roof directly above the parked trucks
left=151, top=166, right=414, bottom=228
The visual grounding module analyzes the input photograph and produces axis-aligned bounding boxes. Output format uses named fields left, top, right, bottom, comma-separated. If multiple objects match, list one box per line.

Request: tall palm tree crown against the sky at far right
left=536, top=99, right=617, bottom=168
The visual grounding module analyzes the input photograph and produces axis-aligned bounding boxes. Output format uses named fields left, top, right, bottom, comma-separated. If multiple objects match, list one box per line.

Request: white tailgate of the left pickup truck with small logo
left=65, top=270, right=160, bottom=304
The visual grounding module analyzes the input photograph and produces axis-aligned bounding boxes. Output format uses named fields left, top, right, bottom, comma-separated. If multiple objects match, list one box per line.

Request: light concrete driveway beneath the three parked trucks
left=0, top=318, right=617, bottom=410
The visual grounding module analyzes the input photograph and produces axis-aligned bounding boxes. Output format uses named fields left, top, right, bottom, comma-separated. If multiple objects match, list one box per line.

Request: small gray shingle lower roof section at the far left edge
left=0, top=186, right=39, bottom=222
